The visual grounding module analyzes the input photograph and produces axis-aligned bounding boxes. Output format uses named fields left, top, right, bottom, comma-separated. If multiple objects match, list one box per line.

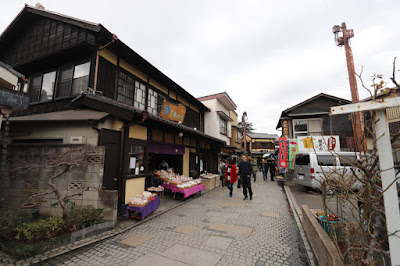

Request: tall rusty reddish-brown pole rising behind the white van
left=332, top=22, right=366, bottom=152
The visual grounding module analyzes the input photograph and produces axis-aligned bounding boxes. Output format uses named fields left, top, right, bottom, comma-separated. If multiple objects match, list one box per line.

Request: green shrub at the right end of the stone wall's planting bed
left=65, top=205, right=103, bottom=231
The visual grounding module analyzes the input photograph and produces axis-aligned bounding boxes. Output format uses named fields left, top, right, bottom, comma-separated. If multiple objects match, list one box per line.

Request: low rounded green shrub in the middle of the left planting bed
left=15, top=217, right=64, bottom=243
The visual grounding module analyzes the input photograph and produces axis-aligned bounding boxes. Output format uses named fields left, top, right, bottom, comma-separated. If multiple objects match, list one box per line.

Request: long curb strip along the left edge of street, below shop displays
left=15, top=187, right=219, bottom=266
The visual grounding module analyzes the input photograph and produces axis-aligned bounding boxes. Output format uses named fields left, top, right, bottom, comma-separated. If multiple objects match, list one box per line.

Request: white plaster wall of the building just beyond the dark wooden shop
left=202, top=99, right=232, bottom=145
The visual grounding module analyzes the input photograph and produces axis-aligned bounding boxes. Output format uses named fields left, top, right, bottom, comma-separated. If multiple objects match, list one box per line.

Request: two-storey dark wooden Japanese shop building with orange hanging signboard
left=0, top=5, right=225, bottom=213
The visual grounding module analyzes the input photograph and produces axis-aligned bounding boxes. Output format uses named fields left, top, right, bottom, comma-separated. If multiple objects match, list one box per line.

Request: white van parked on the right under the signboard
left=294, top=152, right=362, bottom=190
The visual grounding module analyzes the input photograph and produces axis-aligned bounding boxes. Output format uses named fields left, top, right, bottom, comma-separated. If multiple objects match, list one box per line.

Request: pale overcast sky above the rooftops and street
left=0, top=0, right=400, bottom=134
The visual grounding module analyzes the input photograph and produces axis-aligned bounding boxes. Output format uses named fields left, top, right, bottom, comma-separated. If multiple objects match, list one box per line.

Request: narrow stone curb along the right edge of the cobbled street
left=284, top=186, right=318, bottom=266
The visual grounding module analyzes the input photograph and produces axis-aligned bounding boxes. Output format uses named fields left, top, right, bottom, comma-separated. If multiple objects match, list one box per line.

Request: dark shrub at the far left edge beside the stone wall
left=0, top=208, right=31, bottom=239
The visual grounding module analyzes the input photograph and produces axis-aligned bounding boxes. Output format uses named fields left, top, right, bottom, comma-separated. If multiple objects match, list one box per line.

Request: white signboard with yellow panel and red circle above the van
left=297, top=136, right=340, bottom=152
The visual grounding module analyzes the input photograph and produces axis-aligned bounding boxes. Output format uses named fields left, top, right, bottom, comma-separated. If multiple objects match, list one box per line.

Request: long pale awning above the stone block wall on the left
left=9, top=110, right=109, bottom=122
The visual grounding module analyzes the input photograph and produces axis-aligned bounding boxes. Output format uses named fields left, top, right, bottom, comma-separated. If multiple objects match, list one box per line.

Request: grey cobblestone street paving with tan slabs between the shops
left=40, top=173, right=308, bottom=266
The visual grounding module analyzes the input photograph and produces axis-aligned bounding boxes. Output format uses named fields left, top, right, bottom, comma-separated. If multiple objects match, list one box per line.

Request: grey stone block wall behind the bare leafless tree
left=5, top=144, right=118, bottom=220
